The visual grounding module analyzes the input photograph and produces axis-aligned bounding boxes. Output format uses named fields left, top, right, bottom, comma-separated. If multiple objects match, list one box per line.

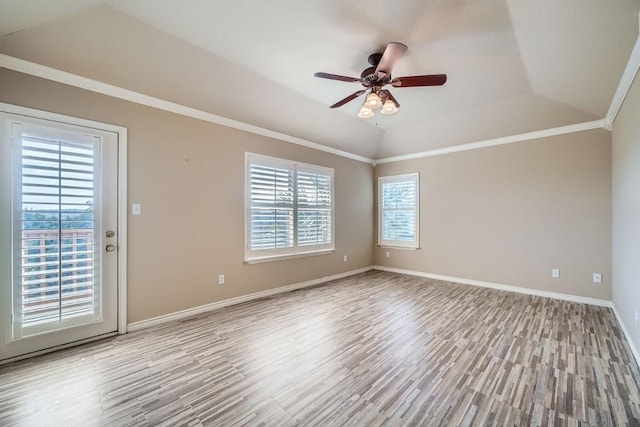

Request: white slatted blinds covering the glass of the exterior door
left=13, top=125, right=101, bottom=338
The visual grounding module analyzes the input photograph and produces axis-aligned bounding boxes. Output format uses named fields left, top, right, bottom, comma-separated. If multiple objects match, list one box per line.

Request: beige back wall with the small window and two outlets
left=375, top=130, right=611, bottom=300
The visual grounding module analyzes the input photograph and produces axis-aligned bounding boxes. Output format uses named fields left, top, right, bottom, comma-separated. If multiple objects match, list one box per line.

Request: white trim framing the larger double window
left=244, top=152, right=336, bottom=264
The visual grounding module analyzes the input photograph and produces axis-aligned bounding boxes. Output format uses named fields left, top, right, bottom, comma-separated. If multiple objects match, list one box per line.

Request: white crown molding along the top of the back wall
left=376, top=119, right=607, bottom=164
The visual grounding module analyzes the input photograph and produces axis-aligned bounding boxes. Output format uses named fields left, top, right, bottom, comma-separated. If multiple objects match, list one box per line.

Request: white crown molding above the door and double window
left=0, top=53, right=375, bottom=165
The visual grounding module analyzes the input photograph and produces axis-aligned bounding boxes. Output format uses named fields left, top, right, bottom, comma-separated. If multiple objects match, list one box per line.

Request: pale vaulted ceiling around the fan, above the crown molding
left=0, top=0, right=640, bottom=158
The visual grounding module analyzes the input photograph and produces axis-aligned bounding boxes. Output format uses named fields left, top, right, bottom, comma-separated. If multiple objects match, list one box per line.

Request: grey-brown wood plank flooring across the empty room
left=0, top=271, right=640, bottom=426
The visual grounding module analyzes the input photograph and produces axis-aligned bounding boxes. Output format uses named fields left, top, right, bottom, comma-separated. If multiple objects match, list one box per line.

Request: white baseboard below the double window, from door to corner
left=127, top=266, right=373, bottom=332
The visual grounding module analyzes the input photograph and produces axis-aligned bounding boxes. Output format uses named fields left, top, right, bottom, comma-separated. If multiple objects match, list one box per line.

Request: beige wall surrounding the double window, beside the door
left=0, top=69, right=374, bottom=322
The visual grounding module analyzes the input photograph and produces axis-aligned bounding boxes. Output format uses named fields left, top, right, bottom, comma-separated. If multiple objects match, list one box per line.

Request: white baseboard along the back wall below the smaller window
left=373, top=265, right=613, bottom=308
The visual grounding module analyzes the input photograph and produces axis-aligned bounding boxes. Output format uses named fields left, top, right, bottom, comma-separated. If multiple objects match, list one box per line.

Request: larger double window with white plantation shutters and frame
left=245, top=153, right=334, bottom=263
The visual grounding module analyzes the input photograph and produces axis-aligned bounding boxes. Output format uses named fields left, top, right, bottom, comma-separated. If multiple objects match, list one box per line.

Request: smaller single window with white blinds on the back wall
left=378, top=173, right=420, bottom=249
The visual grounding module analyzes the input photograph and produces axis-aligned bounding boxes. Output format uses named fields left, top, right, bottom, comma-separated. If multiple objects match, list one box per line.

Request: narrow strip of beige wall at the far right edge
left=612, top=72, right=640, bottom=363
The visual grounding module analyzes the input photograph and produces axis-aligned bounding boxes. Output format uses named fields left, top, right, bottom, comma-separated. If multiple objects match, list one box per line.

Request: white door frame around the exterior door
left=0, top=102, right=128, bottom=358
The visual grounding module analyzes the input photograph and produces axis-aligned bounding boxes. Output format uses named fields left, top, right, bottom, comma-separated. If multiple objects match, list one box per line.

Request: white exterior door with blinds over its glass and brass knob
left=0, top=105, right=121, bottom=360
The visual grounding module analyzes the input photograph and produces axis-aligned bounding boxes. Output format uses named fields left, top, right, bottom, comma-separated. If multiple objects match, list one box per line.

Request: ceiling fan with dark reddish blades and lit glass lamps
left=314, top=42, right=447, bottom=119
